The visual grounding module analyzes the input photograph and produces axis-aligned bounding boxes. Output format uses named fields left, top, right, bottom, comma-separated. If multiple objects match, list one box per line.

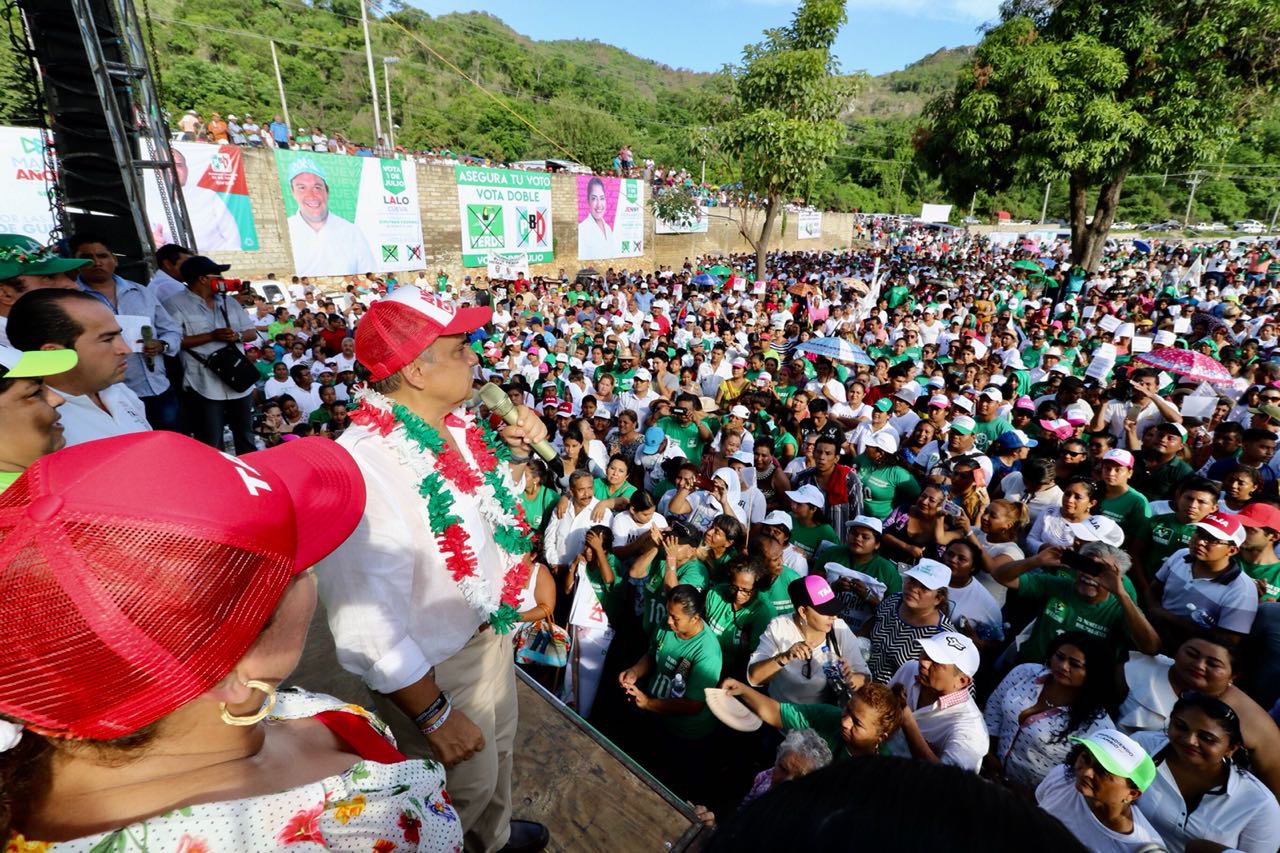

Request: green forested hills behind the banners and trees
left=0, top=0, right=1280, bottom=222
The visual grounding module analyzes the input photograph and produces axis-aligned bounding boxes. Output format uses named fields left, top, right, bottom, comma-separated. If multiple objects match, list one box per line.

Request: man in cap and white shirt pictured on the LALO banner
left=288, top=158, right=378, bottom=275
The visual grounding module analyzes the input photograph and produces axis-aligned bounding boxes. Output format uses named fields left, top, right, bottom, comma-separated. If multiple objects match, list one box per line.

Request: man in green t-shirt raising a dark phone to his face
left=991, top=542, right=1160, bottom=663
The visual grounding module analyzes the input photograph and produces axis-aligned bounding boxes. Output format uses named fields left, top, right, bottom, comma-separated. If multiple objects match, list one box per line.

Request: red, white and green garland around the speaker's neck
left=351, top=389, right=534, bottom=634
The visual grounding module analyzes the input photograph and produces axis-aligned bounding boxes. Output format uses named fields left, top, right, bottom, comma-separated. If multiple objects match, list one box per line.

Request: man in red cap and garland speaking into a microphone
left=317, top=286, right=548, bottom=852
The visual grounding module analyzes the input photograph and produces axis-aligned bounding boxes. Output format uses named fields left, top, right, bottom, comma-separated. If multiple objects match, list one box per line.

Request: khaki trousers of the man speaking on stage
left=374, top=630, right=516, bottom=853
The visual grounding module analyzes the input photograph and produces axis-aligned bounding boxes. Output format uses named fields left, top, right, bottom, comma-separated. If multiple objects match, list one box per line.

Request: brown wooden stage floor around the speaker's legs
left=288, top=606, right=708, bottom=853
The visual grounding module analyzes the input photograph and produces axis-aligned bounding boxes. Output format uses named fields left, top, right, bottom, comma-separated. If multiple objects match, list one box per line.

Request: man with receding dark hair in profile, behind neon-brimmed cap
left=9, top=288, right=151, bottom=447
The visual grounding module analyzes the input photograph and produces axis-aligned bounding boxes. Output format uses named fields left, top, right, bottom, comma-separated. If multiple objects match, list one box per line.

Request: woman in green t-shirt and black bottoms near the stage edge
left=618, top=584, right=723, bottom=802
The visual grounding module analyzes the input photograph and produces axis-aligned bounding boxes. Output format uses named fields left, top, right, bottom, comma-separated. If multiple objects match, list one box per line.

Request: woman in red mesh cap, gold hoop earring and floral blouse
left=0, top=432, right=462, bottom=853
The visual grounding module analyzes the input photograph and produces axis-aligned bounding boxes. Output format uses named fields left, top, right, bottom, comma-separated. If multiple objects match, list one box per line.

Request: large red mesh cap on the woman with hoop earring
left=0, top=432, right=365, bottom=740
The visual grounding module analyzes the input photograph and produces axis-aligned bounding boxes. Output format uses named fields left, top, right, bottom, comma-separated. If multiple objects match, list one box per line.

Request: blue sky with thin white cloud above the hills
left=410, top=0, right=1000, bottom=74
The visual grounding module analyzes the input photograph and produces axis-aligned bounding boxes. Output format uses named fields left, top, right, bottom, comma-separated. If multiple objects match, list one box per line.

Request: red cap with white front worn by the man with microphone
left=356, top=284, right=493, bottom=382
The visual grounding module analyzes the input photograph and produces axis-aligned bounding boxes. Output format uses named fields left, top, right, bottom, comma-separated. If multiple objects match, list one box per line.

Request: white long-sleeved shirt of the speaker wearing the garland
left=316, top=410, right=517, bottom=693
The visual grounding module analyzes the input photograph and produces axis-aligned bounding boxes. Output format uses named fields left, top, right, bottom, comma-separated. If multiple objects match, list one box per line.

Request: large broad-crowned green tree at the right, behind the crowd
left=920, top=0, right=1280, bottom=269
